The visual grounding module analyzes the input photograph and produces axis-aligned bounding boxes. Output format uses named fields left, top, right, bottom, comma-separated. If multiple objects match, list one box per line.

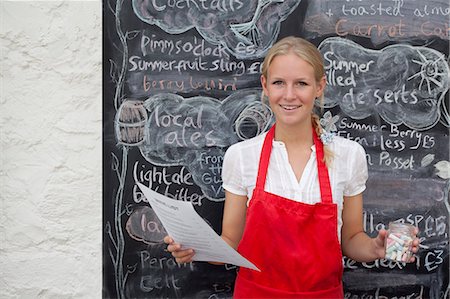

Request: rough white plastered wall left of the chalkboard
left=0, top=0, right=102, bottom=298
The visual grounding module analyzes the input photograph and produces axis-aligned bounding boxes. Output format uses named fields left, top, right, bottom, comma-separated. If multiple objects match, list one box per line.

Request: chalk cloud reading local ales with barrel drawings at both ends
left=115, top=88, right=274, bottom=201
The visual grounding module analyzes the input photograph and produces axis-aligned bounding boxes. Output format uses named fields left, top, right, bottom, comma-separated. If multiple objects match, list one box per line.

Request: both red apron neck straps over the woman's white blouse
left=256, top=125, right=333, bottom=203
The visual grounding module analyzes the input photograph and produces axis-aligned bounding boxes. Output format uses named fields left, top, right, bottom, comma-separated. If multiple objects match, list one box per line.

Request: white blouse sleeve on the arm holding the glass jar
left=344, top=143, right=368, bottom=196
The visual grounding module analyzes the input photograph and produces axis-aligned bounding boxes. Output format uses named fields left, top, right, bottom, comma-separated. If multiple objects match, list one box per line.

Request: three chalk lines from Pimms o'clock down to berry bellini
left=120, top=29, right=268, bottom=98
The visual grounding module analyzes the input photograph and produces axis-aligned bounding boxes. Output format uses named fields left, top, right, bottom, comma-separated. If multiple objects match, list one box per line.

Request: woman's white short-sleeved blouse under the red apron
left=222, top=133, right=368, bottom=240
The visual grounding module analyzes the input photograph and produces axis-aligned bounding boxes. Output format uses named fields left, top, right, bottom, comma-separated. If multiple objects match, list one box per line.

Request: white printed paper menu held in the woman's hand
left=136, top=182, right=260, bottom=271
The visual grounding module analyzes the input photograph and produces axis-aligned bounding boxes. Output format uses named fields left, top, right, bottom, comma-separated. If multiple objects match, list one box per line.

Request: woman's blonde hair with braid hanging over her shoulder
left=261, top=36, right=333, bottom=166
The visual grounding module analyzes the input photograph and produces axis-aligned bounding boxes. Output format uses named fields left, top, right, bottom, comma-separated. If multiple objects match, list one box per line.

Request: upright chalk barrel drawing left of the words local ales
left=114, top=100, right=148, bottom=146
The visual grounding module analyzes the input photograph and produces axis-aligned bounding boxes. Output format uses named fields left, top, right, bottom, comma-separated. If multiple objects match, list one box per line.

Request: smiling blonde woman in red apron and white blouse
left=165, top=37, right=419, bottom=298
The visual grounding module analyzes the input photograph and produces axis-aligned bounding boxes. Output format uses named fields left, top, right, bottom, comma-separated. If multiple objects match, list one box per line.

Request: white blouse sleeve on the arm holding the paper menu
left=222, top=144, right=247, bottom=195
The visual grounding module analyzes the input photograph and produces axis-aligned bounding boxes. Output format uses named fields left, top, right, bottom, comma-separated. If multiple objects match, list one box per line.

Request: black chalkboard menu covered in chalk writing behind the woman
left=103, top=0, right=450, bottom=299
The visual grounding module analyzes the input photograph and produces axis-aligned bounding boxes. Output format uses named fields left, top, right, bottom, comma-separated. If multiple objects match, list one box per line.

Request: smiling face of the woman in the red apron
left=261, top=52, right=325, bottom=127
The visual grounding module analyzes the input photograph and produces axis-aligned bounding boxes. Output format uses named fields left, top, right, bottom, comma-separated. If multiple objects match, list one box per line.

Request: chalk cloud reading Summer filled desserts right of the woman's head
left=319, top=38, right=449, bottom=130
